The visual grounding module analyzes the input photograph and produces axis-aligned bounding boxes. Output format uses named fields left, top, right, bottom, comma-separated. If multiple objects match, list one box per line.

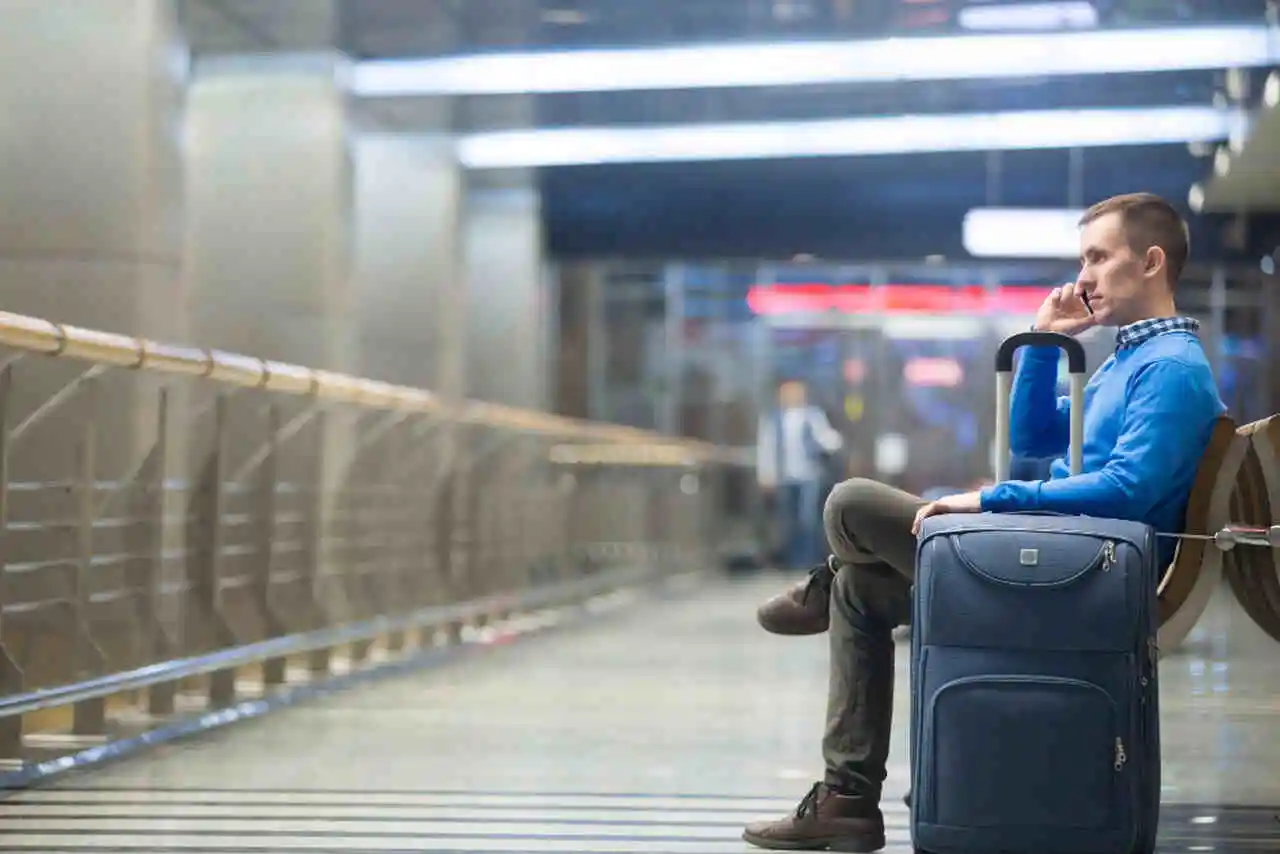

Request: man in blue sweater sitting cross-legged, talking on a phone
left=744, top=193, right=1224, bottom=851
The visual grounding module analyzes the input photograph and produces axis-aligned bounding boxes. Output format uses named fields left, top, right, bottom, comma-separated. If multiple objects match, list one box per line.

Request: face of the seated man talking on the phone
left=1076, top=214, right=1164, bottom=326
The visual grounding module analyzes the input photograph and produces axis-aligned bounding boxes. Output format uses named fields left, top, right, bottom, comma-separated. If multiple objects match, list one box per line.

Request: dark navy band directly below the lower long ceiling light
left=541, top=146, right=1239, bottom=260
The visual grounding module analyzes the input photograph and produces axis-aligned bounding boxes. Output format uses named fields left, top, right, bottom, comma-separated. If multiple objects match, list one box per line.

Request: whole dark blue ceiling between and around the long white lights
left=185, top=0, right=1280, bottom=260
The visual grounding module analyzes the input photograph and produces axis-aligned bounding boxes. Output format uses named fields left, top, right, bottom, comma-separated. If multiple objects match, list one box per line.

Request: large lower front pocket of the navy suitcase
left=922, top=675, right=1128, bottom=831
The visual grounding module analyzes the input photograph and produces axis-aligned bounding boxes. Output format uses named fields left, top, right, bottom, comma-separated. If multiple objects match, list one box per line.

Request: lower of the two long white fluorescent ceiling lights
left=457, top=106, right=1233, bottom=169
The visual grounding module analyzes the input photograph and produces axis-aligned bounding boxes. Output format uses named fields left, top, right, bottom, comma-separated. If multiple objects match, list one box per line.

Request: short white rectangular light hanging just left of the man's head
left=963, top=207, right=1084, bottom=259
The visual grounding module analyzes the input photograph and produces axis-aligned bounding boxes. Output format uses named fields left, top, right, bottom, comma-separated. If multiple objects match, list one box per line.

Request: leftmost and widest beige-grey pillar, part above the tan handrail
left=0, top=0, right=187, bottom=338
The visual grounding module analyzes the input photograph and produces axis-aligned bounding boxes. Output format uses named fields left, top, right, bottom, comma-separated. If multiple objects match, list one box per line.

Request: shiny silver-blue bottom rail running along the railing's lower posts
left=0, top=568, right=652, bottom=718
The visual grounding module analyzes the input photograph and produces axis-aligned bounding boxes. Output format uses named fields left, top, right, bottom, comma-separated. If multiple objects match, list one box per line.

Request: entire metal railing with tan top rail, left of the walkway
left=0, top=312, right=745, bottom=783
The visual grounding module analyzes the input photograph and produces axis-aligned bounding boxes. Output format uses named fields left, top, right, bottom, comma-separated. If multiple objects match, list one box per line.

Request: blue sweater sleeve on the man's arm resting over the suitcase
left=982, top=360, right=1211, bottom=520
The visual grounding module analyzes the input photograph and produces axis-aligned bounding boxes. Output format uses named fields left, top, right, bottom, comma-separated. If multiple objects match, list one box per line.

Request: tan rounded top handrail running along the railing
left=0, top=311, right=736, bottom=462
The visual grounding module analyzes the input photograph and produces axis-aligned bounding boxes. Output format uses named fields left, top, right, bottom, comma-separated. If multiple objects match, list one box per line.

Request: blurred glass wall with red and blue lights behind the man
left=562, top=260, right=1280, bottom=492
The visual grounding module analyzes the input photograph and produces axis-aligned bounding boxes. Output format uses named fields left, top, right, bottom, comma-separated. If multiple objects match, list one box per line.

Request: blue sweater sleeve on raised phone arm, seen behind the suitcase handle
left=1009, top=347, right=1071, bottom=457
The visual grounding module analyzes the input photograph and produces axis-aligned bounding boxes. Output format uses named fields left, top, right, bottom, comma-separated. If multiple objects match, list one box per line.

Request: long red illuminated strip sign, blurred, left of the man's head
left=746, top=284, right=1051, bottom=315
